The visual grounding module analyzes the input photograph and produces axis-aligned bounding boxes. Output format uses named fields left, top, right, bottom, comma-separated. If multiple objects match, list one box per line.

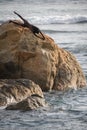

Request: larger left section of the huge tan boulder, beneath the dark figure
left=0, top=23, right=58, bottom=91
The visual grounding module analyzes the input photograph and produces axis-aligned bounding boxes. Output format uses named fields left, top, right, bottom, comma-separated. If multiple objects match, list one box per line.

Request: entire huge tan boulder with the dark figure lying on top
left=0, top=22, right=86, bottom=91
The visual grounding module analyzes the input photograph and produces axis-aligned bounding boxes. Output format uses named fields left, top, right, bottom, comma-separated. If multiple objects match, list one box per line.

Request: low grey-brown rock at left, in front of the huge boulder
left=0, top=79, right=44, bottom=106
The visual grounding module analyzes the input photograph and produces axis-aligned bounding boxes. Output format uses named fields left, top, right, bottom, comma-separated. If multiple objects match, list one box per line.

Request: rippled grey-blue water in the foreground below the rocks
left=0, top=88, right=87, bottom=130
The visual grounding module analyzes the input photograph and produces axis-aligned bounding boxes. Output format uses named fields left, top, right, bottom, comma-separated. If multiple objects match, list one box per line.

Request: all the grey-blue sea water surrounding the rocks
left=0, top=0, right=87, bottom=130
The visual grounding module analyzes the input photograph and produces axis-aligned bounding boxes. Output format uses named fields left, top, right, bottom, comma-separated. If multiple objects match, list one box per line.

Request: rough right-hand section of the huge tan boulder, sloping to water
left=53, top=48, right=86, bottom=90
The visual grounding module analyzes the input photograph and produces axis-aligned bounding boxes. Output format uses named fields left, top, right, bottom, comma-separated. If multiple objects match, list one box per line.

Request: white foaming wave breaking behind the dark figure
left=28, top=15, right=87, bottom=24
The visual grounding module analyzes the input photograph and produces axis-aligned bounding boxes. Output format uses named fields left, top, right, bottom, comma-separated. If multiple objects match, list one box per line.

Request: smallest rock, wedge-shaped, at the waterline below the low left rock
left=6, top=95, right=47, bottom=111
